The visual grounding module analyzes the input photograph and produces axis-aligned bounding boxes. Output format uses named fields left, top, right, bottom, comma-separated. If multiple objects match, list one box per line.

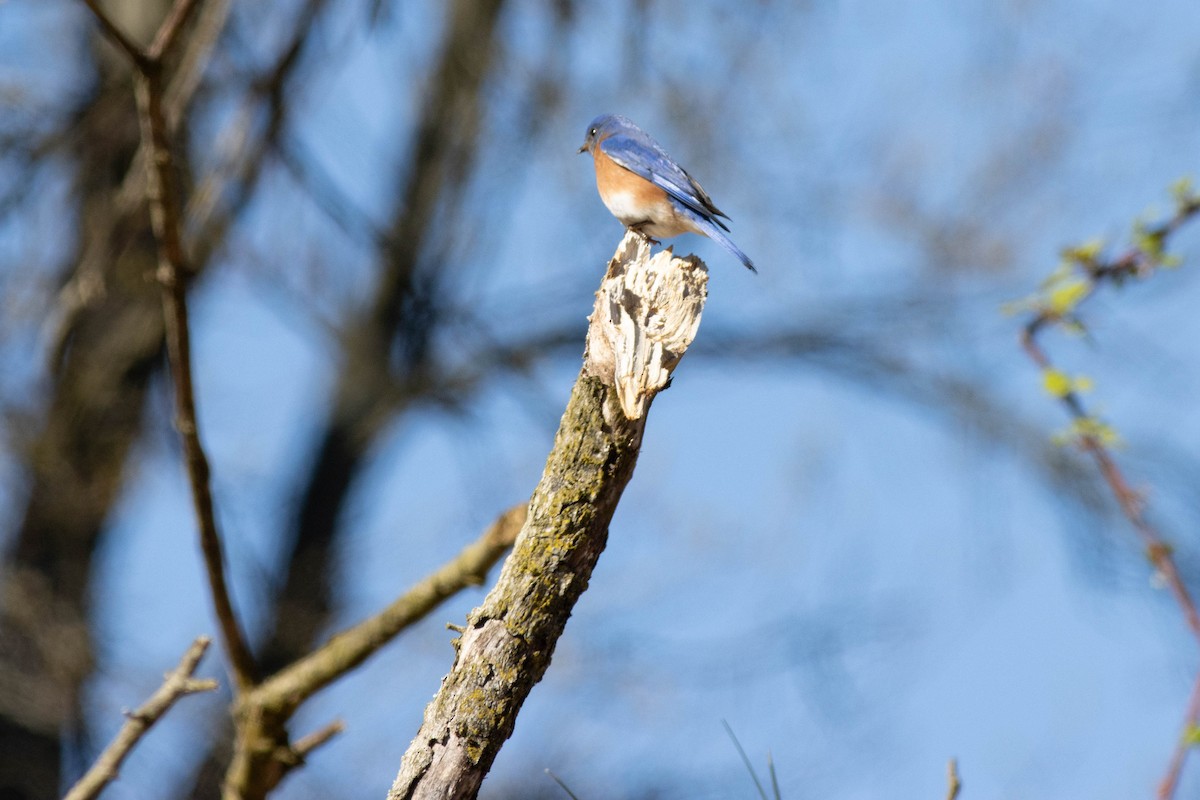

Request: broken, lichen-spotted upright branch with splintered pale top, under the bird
left=388, top=234, right=708, bottom=800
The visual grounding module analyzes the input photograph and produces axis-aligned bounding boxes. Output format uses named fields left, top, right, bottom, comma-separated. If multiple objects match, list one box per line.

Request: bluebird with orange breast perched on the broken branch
left=580, top=114, right=758, bottom=272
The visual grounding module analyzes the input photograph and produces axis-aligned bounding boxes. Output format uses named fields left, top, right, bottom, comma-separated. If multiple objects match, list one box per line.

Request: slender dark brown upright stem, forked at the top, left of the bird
left=84, top=0, right=258, bottom=691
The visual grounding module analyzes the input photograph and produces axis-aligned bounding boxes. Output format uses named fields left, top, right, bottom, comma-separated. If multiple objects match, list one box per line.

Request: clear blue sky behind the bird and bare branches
left=7, top=0, right=1200, bottom=800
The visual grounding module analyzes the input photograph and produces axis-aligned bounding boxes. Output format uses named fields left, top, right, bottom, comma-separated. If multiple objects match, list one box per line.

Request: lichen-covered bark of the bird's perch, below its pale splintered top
left=389, top=373, right=646, bottom=798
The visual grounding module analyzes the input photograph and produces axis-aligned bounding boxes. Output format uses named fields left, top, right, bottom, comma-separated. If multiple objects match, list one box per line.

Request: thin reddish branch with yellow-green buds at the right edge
left=1021, top=193, right=1200, bottom=800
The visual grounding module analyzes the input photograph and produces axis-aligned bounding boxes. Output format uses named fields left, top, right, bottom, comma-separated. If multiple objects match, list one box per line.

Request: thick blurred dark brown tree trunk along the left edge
left=0, top=0, right=199, bottom=798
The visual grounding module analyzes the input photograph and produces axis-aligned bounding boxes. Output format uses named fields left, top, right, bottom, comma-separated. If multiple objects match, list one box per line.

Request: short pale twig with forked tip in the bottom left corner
left=65, top=636, right=217, bottom=800
